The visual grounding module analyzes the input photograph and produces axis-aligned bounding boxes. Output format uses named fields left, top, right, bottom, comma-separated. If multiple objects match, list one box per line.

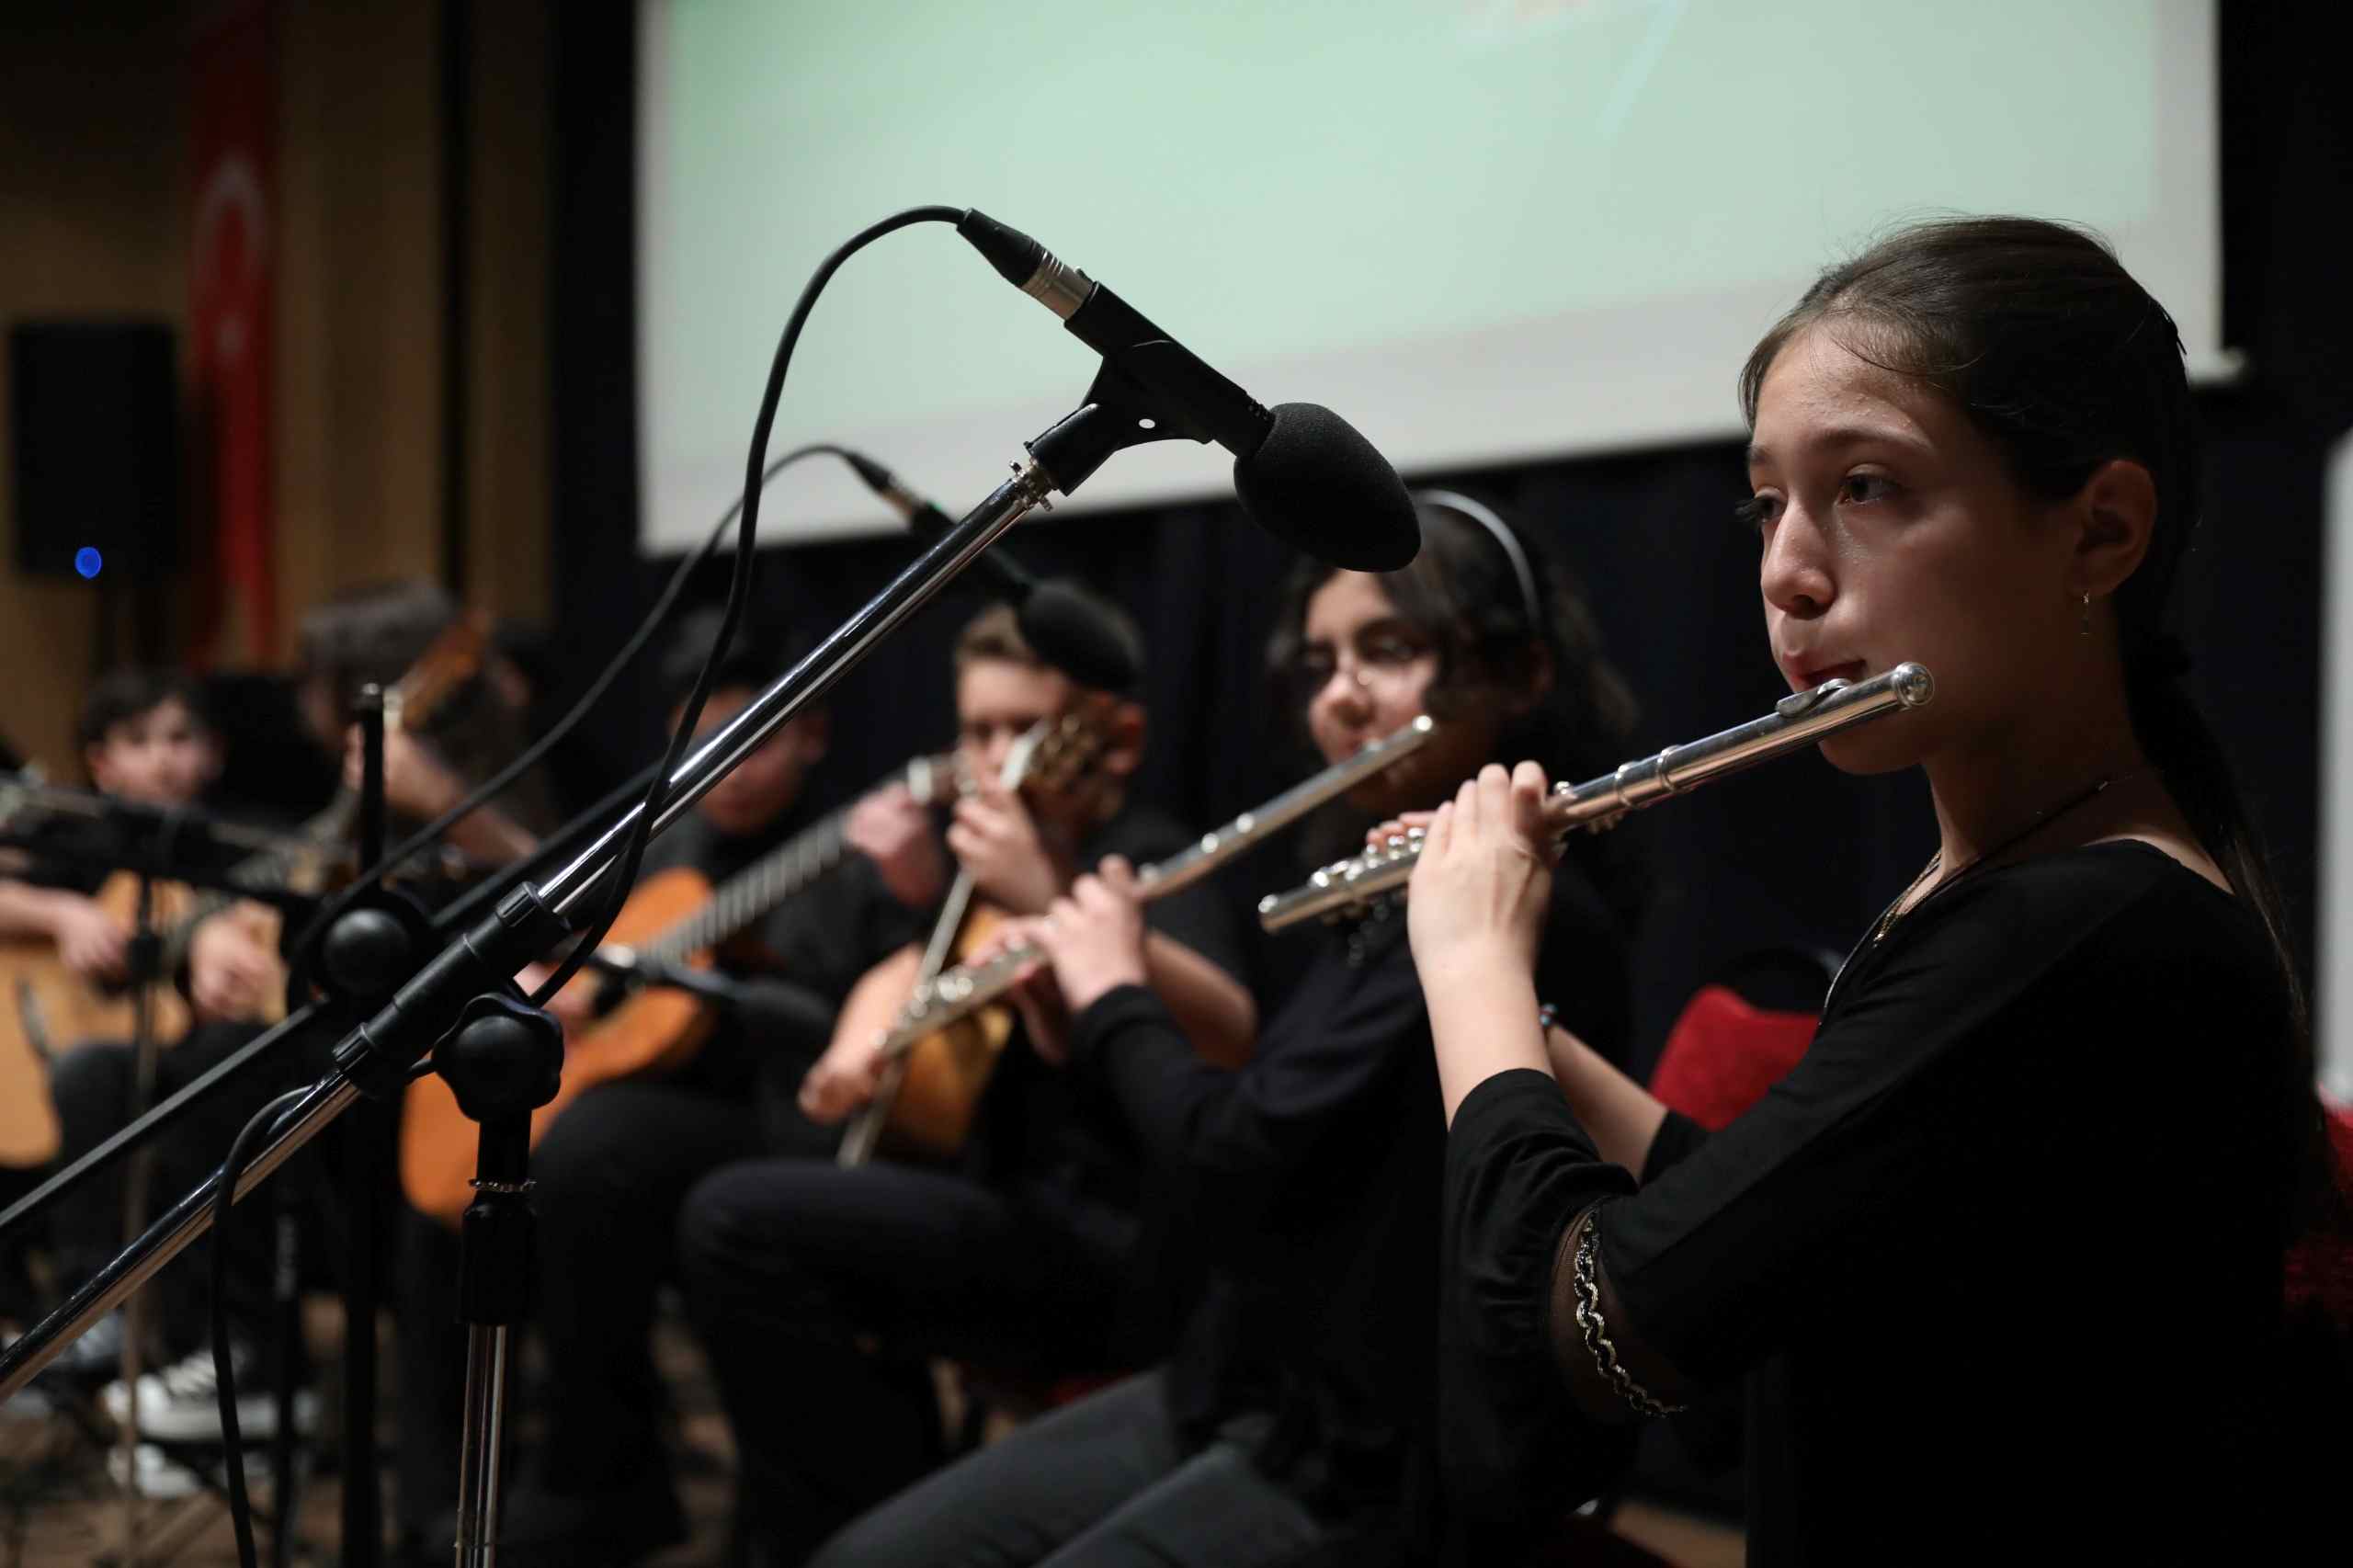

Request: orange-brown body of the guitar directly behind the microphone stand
left=400, top=867, right=713, bottom=1224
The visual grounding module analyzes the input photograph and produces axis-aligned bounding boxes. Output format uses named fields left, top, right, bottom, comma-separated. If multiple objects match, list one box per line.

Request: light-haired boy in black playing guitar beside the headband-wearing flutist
left=680, top=605, right=1256, bottom=1563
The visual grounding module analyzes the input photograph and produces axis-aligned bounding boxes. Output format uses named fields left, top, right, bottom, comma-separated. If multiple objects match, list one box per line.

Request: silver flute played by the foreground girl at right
left=1259, top=664, right=1937, bottom=930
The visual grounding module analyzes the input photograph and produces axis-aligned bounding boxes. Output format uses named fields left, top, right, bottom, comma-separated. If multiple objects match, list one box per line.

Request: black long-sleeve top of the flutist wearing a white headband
left=1073, top=871, right=1626, bottom=1544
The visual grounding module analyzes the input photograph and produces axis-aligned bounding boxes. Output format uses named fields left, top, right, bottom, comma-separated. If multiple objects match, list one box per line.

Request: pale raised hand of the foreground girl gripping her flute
left=1404, top=763, right=1560, bottom=989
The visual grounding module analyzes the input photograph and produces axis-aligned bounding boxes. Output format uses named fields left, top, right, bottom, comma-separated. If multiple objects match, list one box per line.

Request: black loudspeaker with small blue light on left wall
left=7, top=320, right=179, bottom=577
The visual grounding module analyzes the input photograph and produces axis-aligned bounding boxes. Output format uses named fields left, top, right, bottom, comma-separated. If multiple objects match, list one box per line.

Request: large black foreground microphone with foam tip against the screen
left=955, top=207, right=1421, bottom=572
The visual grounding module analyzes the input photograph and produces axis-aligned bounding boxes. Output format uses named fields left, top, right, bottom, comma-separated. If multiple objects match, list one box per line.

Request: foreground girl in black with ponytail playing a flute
left=1409, top=219, right=2344, bottom=1563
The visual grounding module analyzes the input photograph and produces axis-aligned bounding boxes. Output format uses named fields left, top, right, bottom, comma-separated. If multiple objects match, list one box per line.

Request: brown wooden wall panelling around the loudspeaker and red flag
left=0, top=0, right=551, bottom=766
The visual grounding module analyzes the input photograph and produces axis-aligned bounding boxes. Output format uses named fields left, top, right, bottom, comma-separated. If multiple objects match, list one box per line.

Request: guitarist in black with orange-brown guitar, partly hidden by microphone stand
left=472, top=612, right=941, bottom=1563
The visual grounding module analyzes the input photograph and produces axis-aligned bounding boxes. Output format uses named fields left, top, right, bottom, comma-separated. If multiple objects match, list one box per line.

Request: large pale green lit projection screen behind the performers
left=638, top=0, right=2222, bottom=549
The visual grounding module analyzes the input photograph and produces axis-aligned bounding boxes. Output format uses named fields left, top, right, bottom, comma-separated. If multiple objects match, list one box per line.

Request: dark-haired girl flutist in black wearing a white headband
left=800, top=494, right=1633, bottom=1568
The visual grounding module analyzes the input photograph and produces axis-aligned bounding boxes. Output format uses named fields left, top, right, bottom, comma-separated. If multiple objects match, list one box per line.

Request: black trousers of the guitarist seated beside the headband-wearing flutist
left=680, top=1143, right=1127, bottom=1563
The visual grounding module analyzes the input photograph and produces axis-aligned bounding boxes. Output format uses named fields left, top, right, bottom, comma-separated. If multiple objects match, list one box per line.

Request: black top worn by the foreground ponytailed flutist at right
left=1442, top=843, right=2306, bottom=1563
